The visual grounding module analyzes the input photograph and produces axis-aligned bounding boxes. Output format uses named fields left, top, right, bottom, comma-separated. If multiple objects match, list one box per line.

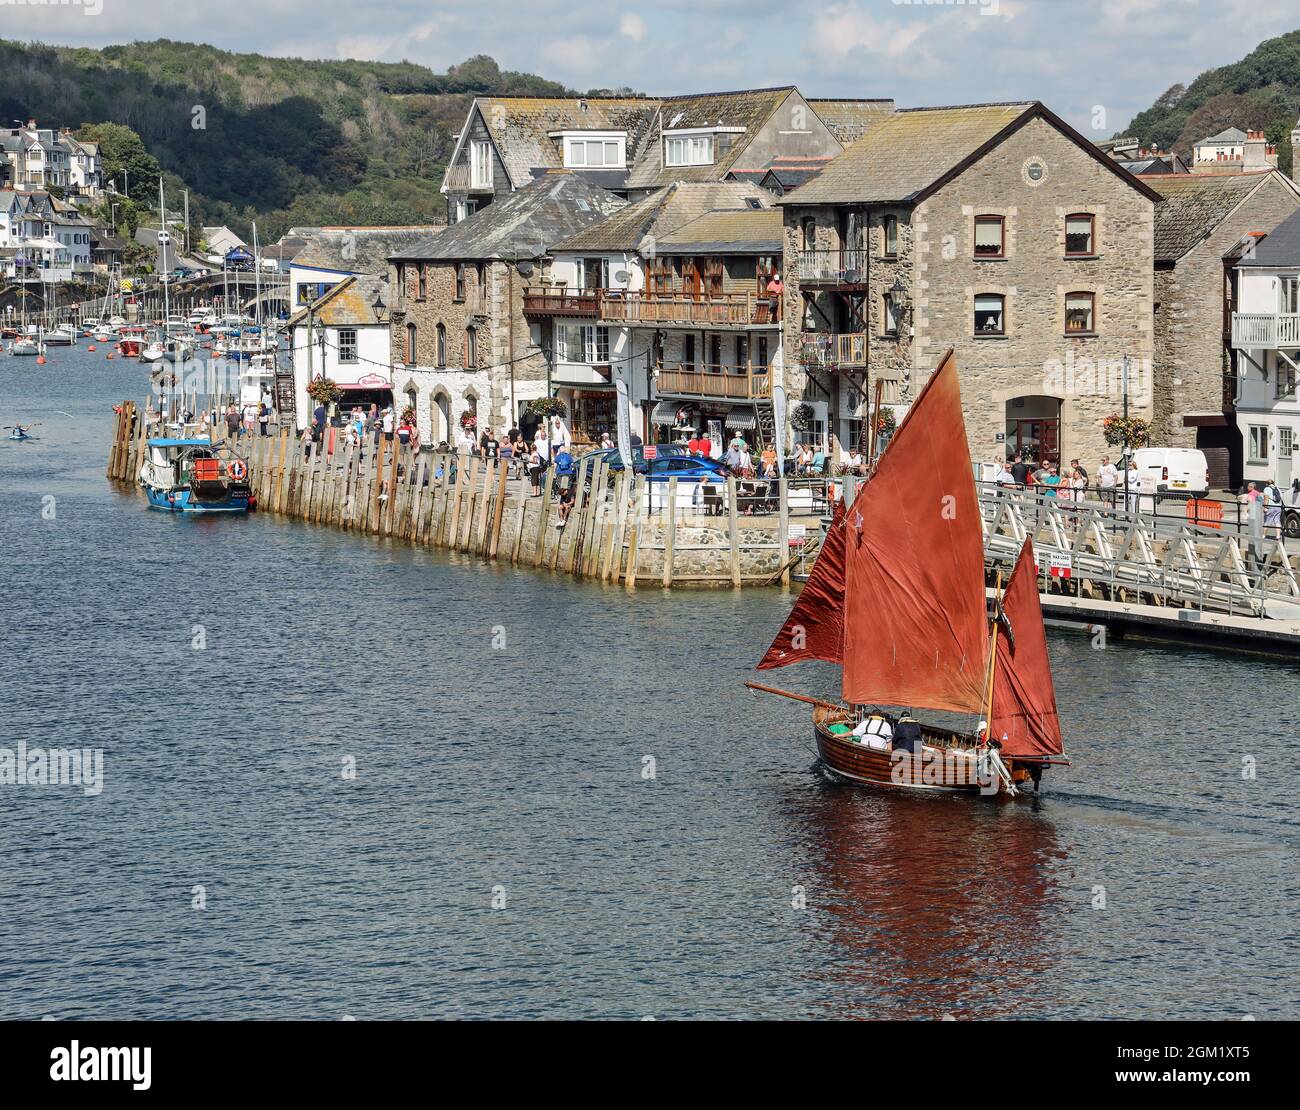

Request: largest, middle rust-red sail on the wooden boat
left=844, top=352, right=988, bottom=714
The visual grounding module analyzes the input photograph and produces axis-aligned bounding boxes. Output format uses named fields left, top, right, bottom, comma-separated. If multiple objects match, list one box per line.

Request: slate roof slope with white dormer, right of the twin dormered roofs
left=627, top=84, right=796, bottom=188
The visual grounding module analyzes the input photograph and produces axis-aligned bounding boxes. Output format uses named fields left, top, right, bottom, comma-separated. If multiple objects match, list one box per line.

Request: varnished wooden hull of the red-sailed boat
left=813, top=706, right=1030, bottom=797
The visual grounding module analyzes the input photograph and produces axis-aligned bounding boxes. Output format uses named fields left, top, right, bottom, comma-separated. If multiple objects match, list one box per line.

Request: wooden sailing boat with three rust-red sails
left=746, top=351, right=1069, bottom=797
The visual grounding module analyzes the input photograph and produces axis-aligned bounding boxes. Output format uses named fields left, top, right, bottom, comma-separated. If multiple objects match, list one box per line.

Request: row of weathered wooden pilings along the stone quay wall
left=108, top=402, right=797, bottom=589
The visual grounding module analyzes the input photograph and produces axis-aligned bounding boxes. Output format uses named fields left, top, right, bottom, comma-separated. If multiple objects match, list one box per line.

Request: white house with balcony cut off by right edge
left=1232, top=212, right=1300, bottom=486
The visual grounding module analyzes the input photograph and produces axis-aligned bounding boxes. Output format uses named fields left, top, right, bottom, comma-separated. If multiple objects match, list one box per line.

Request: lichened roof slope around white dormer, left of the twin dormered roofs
left=467, top=96, right=659, bottom=188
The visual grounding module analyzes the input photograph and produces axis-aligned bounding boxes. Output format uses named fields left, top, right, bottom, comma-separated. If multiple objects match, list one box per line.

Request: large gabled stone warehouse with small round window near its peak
left=777, top=103, right=1160, bottom=470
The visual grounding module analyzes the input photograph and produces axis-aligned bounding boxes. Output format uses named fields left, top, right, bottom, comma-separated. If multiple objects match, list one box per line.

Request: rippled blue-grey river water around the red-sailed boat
left=0, top=348, right=1300, bottom=1019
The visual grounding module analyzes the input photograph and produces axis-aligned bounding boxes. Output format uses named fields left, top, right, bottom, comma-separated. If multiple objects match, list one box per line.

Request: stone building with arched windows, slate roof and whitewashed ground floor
left=389, top=170, right=627, bottom=443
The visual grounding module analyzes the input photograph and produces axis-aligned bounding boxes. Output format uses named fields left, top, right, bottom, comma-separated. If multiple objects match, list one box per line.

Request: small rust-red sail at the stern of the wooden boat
left=989, top=539, right=1063, bottom=756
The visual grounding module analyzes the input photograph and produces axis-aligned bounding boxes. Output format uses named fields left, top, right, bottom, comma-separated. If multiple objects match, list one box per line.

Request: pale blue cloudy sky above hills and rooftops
left=0, top=0, right=1300, bottom=138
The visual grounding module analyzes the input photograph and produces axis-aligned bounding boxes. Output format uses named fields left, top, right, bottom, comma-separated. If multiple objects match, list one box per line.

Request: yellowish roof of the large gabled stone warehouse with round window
left=777, top=101, right=1156, bottom=204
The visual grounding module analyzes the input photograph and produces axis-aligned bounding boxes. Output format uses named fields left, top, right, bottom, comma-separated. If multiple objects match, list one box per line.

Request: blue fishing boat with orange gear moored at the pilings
left=140, top=437, right=256, bottom=513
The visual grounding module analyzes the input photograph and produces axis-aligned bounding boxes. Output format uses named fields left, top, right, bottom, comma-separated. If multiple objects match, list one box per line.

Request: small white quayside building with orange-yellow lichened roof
left=289, top=276, right=393, bottom=429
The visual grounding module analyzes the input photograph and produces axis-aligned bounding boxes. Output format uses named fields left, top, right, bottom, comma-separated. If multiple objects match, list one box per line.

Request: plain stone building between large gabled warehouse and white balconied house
left=1144, top=169, right=1300, bottom=489
